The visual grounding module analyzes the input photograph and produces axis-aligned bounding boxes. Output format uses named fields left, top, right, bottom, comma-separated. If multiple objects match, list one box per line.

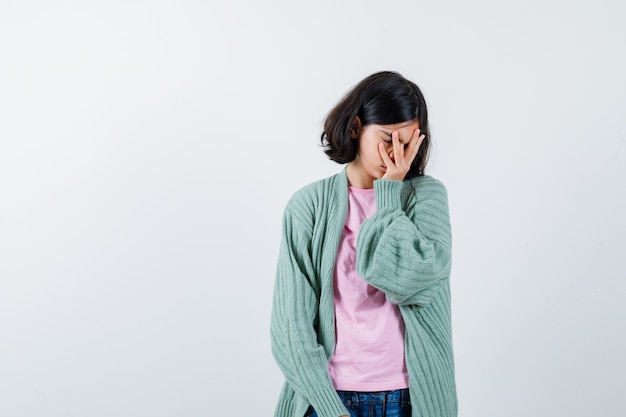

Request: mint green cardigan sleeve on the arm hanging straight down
left=270, top=198, right=349, bottom=417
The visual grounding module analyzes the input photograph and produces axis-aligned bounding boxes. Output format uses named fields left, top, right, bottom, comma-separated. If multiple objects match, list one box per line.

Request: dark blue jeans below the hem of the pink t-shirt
left=304, top=389, right=411, bottom=417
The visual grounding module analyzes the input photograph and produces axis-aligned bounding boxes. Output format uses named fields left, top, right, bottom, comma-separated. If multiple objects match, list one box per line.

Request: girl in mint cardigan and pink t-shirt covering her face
left=271, top=72, right=457, bottom=417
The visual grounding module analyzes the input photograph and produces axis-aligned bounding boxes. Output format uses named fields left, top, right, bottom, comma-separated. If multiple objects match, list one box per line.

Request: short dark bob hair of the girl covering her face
left=321, top=71, right=430, bottom=179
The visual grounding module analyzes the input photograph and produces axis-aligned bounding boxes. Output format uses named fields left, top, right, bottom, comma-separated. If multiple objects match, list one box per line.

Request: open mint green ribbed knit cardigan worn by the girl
left=270, top=169, right=457, bottom=417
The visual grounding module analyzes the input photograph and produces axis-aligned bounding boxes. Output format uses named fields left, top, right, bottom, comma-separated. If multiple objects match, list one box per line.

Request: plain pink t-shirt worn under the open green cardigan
left=329, top=187, right=409, bottom=391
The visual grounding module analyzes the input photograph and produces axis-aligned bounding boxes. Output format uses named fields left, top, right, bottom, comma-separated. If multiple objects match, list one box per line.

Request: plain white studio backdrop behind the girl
left=0, top=0, right=626, bottom=417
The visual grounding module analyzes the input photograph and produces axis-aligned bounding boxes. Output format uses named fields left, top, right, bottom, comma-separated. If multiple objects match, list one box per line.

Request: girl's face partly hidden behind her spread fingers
left=347, top=120, right=419, bottom=188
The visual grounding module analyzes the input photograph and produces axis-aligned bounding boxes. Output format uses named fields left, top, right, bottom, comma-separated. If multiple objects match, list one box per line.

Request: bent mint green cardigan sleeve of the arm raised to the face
left=357, top=177, right=452, bottom=305
